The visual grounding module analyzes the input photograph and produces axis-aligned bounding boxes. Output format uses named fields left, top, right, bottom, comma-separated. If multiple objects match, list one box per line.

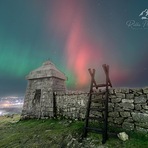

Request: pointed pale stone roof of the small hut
left=26, top=61, right=67, bottom=80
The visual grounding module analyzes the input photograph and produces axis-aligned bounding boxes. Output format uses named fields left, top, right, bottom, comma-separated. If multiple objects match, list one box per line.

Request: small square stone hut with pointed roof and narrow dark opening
left=22, top=61, right=67, bottom=119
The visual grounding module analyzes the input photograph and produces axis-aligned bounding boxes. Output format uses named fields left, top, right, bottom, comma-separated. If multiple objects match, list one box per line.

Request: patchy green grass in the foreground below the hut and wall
left=0, top=115, right=148, bottom=148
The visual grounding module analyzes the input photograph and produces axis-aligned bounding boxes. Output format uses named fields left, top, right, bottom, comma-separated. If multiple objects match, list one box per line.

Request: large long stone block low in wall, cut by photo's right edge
left=131, top=112, right=148, bottom=122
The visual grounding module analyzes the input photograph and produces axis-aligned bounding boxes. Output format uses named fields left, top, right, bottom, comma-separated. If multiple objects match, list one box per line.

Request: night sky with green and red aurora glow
left=0, top=0, right=148, bottom=96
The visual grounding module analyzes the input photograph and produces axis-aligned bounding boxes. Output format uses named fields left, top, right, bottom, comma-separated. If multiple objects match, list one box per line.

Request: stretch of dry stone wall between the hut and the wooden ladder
left=56, top=92, right=88, bottom=119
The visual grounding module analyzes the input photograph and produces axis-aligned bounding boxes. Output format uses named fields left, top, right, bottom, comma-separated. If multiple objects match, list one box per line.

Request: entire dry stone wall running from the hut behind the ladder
left=56, top=88, right=148, bottom=132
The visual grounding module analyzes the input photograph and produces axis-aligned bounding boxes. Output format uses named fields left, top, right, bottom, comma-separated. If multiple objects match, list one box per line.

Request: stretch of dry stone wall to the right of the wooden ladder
left=108, top=88, right=148, bottom=132
